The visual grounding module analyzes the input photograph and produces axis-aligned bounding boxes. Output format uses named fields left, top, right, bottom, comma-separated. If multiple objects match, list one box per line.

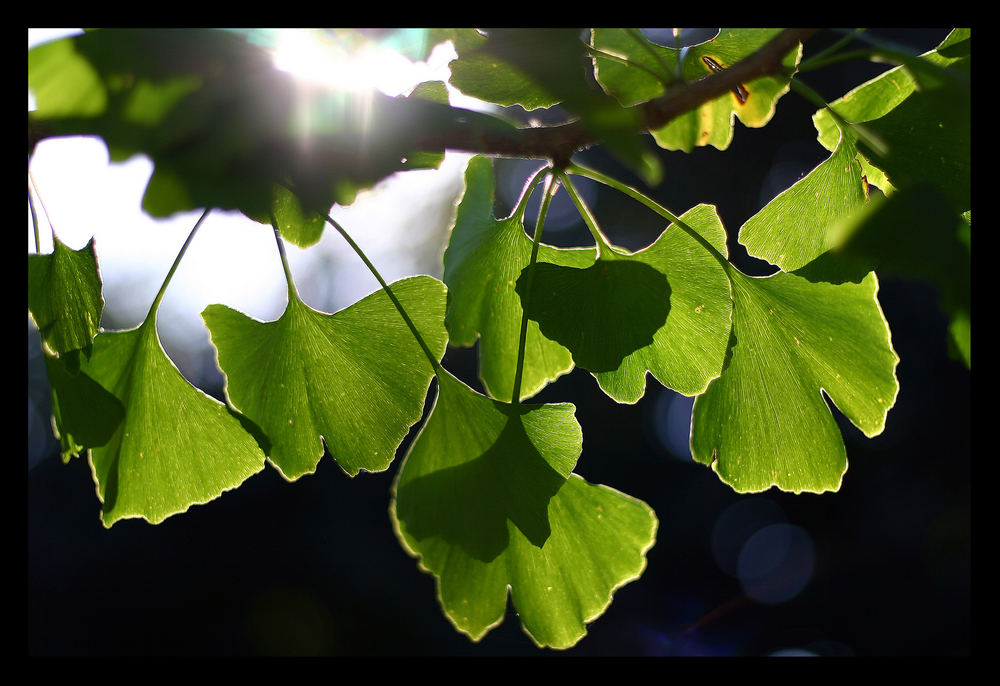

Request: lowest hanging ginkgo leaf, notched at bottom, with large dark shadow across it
left=390, top=372, right=657, bottom=648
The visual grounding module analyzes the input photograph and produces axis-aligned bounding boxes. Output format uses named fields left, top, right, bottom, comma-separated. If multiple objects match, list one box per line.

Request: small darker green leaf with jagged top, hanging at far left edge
left=28, top=235, right=104, bottom=355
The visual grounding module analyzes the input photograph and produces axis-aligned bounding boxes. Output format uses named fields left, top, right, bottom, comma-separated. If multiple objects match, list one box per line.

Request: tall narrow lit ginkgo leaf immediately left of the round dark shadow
left=444, top=157, right=595, bottom=400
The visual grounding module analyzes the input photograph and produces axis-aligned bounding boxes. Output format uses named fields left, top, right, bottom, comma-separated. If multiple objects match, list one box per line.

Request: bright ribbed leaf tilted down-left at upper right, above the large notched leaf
left=740, top=135, right=867, bottom=272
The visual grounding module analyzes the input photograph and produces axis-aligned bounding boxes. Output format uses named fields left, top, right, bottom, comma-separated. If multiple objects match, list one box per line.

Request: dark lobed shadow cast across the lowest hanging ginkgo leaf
left=396, top=403, right=566, bottom=562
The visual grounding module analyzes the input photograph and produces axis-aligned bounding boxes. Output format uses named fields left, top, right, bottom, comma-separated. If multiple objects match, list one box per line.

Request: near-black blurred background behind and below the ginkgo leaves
left=26, top=29, right=971, bottom=656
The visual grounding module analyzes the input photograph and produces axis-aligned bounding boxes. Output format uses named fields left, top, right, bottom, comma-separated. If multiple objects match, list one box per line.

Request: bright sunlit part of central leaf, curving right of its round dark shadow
left=591, top=205, right=732, bottom=403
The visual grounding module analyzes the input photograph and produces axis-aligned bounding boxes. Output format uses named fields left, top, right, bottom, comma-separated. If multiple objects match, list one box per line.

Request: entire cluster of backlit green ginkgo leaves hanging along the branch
left=28, top=29, right=971, bottom=648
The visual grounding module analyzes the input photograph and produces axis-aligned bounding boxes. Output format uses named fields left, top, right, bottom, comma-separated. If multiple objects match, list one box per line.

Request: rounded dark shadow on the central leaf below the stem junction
left=516, top=259, right=670, bottom=372
